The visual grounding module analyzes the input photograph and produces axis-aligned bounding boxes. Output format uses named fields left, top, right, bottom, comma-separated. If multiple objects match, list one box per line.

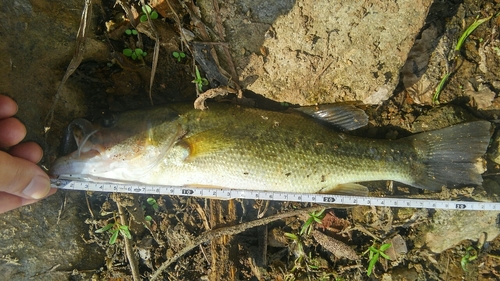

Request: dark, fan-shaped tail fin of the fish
left=408, top=121, right=491, bottom=190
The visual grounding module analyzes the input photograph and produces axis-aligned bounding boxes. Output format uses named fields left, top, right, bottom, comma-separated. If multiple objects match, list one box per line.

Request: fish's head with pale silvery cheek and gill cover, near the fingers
left=49, top=108, right=182, bottom=181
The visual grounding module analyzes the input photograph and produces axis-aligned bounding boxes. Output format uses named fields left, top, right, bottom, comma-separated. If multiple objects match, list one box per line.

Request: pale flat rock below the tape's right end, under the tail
left=420, top=210, right=500, bottom=253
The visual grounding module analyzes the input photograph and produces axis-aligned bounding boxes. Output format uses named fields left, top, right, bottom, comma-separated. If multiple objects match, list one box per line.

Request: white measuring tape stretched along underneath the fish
left=51, top=179, right=500, bottom=211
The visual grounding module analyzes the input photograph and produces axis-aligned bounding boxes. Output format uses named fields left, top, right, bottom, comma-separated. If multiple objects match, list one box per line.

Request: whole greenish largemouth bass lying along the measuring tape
left=50, top=101, right=490, bottom=195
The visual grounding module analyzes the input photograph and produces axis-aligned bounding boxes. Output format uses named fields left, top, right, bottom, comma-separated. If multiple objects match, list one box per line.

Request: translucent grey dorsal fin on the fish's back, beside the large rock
left=295, top=104, right=368, bottom=131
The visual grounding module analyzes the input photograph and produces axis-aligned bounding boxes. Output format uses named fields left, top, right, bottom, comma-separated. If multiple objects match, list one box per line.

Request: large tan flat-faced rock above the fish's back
left=235, top=0, right=432, bottom=105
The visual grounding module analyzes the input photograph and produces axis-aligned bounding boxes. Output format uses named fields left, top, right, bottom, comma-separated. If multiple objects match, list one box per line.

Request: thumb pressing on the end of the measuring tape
left=0, top=151, right=50, bottom=199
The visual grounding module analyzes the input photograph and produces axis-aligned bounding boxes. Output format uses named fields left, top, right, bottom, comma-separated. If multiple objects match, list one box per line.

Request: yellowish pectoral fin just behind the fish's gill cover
left=180, top=128, right=235, bottom=160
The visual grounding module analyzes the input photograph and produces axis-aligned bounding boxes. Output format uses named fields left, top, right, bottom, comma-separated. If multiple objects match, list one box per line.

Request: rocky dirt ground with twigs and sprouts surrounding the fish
left=0, top=0, right=500, bottom=281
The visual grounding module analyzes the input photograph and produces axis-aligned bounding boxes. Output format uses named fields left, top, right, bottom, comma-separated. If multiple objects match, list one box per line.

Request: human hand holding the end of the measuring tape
left=0, top=95, right=56, bottom=213
